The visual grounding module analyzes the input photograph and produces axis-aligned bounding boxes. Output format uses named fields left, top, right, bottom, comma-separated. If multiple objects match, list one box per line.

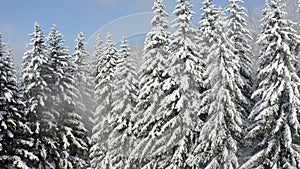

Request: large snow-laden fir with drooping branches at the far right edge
left=241, top=0, right=300, bottom=169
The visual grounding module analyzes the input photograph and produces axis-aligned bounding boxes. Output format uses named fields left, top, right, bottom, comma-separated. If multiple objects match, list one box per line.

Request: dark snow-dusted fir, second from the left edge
left=22, top=22, right=59, bottom=168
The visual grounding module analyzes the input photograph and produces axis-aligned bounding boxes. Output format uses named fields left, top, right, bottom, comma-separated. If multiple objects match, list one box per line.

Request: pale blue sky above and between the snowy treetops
left=0, top=0, right=264, bottom=64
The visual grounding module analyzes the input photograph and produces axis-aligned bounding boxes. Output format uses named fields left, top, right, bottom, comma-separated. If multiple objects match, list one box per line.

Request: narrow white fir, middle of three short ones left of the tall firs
left=90, top=33, right=118, bottom=169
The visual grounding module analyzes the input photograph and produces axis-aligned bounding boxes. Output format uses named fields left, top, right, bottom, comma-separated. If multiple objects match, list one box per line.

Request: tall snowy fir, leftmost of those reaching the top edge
left=131, top=0, right=170, bottom=166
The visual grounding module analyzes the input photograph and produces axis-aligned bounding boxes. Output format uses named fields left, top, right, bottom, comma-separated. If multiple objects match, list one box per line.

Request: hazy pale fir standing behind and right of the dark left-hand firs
left=73, top=32, right=95, bottom=136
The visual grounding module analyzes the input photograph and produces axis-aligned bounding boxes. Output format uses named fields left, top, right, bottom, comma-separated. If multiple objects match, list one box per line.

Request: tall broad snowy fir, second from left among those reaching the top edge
left=131, top=0, right=204, bottom=168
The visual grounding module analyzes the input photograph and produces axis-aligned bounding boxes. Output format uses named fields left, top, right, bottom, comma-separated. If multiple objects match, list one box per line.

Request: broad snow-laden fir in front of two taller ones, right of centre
left=188, top=10, right=246, bottom=169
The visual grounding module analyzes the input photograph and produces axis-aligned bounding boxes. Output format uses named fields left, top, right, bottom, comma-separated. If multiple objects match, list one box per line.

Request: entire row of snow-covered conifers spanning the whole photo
left=0, top=0, right=300, bottom=169
